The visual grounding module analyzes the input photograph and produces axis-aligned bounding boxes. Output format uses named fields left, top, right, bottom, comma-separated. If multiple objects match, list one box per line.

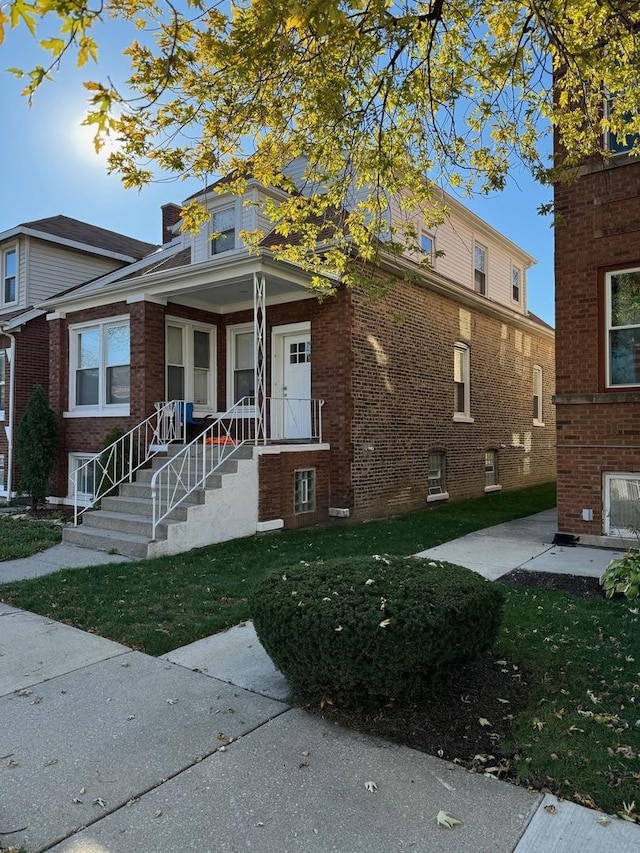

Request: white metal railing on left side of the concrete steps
left=69, top=400, right=184, bottom=525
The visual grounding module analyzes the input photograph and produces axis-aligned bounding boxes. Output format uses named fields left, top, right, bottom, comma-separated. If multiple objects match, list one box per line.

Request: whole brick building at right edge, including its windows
left=555, top=130, right=640, bottom=547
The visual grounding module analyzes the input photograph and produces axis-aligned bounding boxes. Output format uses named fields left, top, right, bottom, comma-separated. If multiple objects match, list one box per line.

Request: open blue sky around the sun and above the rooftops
left=0, top=22, right=554, bottom=324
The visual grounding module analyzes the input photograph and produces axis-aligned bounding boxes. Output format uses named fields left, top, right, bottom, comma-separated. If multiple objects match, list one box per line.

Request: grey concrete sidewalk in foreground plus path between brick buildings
left=0, top=510, right=640, bottom=853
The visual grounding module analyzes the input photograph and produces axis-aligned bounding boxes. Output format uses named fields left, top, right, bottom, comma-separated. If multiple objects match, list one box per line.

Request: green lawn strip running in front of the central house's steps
left=0, top=484, right=555, bottom=655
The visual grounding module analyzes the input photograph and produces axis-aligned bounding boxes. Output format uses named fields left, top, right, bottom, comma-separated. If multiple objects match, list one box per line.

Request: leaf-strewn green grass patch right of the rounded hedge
left=498, top=588, right=640, bottom=820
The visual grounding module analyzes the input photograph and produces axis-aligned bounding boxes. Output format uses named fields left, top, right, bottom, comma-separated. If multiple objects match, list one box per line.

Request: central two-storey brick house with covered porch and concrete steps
left=37, top=176, right=555, bottom=556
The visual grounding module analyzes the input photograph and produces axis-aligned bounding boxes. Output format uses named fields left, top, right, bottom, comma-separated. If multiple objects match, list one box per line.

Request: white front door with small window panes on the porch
left=282, top=332, right=311, bottom=438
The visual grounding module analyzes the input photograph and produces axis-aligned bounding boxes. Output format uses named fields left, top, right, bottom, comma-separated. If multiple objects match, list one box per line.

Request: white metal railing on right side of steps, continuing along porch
left=151, top=397, right=324, bottom=539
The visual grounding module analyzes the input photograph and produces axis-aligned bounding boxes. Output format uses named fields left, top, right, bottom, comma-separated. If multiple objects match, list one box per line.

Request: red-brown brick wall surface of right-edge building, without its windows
left=555, top=159, right=640, bottom=544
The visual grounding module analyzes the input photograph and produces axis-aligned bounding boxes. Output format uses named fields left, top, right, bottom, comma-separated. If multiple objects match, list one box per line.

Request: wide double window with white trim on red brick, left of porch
left=69, top=317, right=131, bottom=413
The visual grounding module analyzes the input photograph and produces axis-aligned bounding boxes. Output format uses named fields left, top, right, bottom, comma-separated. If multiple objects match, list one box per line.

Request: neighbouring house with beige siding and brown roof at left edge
left=0, top=216, right=154, bottom=499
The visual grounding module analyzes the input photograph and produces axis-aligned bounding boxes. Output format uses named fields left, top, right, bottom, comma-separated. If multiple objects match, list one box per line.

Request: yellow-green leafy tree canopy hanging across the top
left=0, top=0, right=640, bottom=280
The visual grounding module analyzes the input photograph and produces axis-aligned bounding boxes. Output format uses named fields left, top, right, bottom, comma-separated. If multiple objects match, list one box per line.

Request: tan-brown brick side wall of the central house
left=344, top=282, right=555, bottom=517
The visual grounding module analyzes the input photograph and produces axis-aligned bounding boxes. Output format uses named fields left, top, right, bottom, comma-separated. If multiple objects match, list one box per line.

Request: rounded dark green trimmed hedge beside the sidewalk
left=252, top=557, right=503, bottom=704
